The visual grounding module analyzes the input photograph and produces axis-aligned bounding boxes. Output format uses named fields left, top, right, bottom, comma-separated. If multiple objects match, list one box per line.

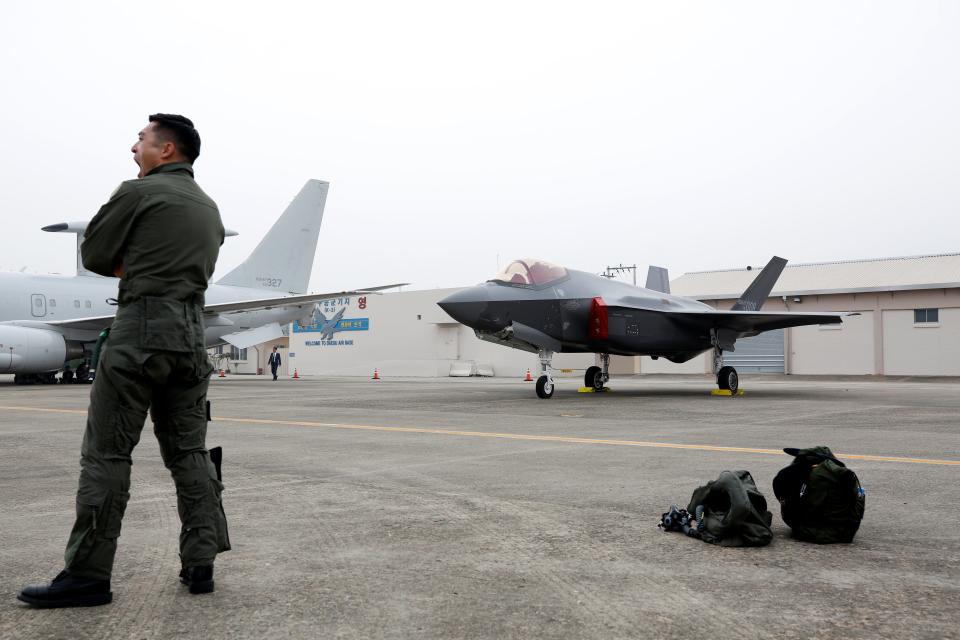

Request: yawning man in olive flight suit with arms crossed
left=19, top=113, right=230, bottom=607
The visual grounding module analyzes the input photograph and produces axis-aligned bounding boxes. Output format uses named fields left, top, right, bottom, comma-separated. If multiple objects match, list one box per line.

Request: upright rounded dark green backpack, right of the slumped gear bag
left=773, top=447, right=866, bottom=544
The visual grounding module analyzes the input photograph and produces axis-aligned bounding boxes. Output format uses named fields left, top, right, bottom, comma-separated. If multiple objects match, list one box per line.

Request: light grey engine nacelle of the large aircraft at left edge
left=0, top=325, right=83, bottom=373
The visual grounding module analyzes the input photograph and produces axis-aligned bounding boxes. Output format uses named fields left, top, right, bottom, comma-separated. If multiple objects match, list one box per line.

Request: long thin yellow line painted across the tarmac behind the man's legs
left=0, top=406, right=960, bottom=466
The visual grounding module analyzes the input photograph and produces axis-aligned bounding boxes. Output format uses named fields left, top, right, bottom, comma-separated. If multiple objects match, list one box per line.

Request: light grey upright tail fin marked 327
left=217, top=180, right=330, bottom=293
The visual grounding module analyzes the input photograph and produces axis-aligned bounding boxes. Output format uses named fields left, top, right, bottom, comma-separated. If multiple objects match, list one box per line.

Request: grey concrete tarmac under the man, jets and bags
left=0, top=375, right=960, bottom=639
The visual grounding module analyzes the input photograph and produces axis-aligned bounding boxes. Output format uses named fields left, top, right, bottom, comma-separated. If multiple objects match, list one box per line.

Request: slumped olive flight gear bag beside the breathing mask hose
left=687, top=471, right=773, bottom=547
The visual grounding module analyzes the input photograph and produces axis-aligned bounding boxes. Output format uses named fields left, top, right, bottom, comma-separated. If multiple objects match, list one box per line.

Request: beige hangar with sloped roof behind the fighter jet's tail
left=619, top=254, right=960, bottom=376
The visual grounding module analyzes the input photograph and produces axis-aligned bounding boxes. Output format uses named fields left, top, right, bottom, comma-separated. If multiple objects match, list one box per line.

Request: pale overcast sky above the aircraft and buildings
left=0, top=0, right=960, bottom=291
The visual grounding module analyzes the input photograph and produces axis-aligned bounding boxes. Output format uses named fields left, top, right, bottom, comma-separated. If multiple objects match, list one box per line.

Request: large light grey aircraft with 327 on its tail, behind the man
left=0, top=180, right=398, bottom=383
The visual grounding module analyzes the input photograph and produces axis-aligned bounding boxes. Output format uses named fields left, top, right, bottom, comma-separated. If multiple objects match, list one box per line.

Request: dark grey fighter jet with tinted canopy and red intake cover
left=438, top=256, right=851, bottom=398
